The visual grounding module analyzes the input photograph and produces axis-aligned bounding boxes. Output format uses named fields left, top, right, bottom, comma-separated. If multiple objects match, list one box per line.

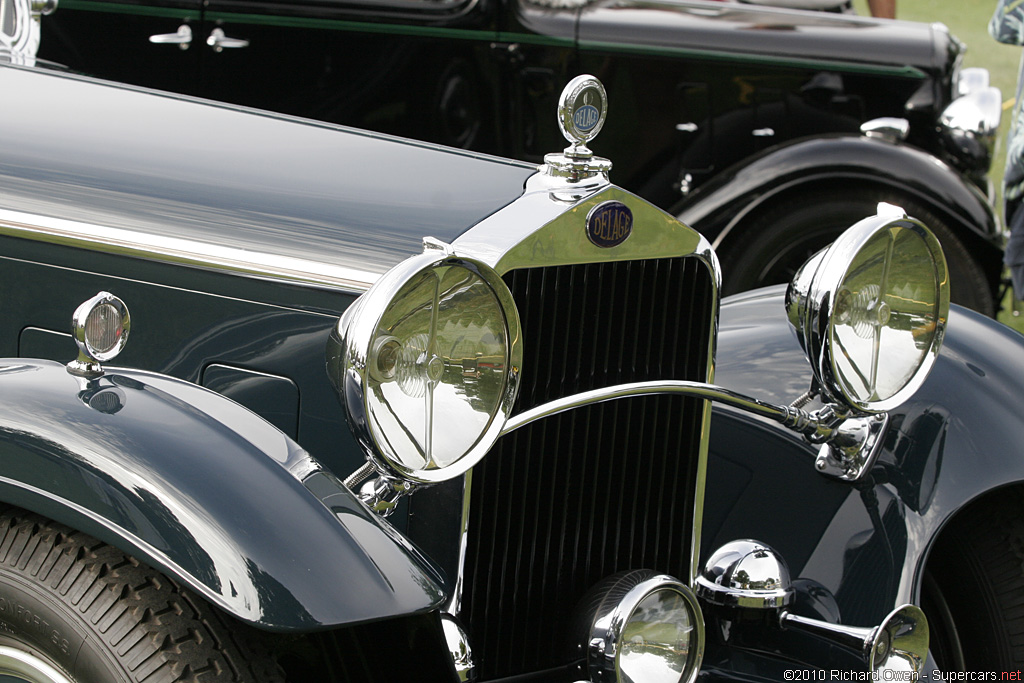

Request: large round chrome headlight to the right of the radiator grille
left=786, top=205, right=949, bottom=413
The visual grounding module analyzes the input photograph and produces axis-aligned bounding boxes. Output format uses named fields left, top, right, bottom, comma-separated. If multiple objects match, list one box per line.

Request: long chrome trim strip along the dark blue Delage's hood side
left=0, top=209, right=380, bottom=294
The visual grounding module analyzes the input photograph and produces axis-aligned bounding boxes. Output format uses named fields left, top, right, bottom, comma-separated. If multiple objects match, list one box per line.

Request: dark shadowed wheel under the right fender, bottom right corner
left=922, top=490, right=1024, bottom=672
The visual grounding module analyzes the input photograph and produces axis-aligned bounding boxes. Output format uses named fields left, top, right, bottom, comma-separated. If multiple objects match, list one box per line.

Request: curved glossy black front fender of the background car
left=675, top=135, right=1001, bottom=282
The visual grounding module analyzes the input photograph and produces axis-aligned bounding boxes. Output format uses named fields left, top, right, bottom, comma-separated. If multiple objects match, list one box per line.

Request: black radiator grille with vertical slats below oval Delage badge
left=463, top=257, right=714, bottom=679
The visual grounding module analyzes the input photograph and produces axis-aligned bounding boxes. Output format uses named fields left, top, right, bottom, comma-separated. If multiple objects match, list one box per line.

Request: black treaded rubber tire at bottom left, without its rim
left=0, top=508, right=285, bottom=683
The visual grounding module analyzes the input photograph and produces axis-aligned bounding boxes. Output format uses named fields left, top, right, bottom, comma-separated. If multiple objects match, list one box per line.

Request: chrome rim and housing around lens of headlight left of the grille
left=328, top=250, right=522, bottom=484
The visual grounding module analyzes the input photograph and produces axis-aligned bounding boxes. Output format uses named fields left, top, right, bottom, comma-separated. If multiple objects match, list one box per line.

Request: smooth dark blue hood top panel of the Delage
left=0, top=69, right=532, bottom=282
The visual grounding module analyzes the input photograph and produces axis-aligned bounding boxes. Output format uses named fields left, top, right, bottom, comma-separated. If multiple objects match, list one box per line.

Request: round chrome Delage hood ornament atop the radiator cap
left=544, top=75, right=611, bottom=182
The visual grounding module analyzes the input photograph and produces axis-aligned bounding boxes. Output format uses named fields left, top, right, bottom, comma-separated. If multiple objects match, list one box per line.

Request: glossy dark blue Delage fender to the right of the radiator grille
left=701, top=288, right=1024, bottom=672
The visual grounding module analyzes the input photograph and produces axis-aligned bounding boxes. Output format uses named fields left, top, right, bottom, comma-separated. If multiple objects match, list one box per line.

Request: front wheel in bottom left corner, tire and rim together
left=0, top=509, right=285, bottom=683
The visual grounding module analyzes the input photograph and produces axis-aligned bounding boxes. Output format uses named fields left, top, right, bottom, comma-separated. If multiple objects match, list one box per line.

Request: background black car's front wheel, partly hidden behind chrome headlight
left=719, top=189, right=995, bottom=316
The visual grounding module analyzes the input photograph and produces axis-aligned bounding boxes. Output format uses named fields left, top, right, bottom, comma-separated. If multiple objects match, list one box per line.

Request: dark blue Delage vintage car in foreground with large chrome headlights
left=0, top=0, right=1024, bottom=683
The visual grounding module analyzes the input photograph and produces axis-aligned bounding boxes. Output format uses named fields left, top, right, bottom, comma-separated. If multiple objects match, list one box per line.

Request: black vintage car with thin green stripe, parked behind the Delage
left=40, top=0, right=1002, bottom=314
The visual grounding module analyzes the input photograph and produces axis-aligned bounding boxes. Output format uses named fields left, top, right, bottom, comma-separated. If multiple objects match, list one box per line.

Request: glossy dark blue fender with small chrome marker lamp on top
left=0, top=358, right=444, bottom=631
